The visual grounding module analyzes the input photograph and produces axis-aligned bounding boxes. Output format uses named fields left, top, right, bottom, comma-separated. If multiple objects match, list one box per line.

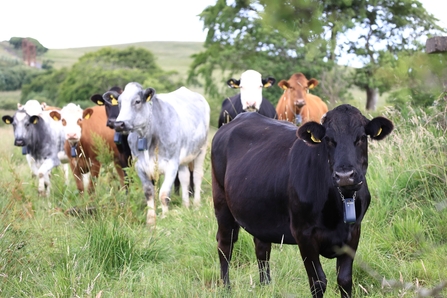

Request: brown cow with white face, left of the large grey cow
left=50, top=103, right=124, bottom=193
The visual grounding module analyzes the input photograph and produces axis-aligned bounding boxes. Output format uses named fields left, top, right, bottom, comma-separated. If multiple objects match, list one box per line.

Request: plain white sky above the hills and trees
left=0, top=0, right=447, bottom=49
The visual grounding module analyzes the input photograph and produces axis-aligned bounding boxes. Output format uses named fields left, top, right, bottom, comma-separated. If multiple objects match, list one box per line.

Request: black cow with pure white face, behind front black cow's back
left=218, top=70, right=277, bottom=127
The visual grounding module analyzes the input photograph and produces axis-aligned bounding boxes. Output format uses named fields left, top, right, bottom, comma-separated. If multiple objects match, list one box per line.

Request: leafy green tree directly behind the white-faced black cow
left=188, top=0, right=331, bottom=105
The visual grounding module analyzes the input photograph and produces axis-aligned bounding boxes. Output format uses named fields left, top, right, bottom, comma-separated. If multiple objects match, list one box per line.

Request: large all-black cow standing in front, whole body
left=211, top=105, right=393, bottom=297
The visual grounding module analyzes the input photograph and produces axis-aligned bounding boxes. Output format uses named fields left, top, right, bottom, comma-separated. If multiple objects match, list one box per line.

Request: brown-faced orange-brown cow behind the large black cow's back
left=276, top=73, right=328, bottom=125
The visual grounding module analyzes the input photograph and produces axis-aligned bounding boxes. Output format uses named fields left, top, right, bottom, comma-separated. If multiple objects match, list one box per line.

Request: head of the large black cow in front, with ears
left=297, top=105, right=393, bottom=194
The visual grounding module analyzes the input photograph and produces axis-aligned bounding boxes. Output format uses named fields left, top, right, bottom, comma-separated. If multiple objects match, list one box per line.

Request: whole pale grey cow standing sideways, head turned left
left=103, top=82, right=210, bottom=225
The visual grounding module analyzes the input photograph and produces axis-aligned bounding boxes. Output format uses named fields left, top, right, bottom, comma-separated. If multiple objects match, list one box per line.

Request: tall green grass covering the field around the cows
left=0, top=98, right=447, bottom=297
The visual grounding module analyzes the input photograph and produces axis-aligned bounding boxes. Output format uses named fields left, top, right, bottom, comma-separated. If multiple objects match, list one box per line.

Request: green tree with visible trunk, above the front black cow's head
left=345, top=0, right=442, bottom=110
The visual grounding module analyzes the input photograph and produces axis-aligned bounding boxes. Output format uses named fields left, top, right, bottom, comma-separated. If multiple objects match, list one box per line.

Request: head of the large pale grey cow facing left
left=114, top=82, right=155, bottom=132
